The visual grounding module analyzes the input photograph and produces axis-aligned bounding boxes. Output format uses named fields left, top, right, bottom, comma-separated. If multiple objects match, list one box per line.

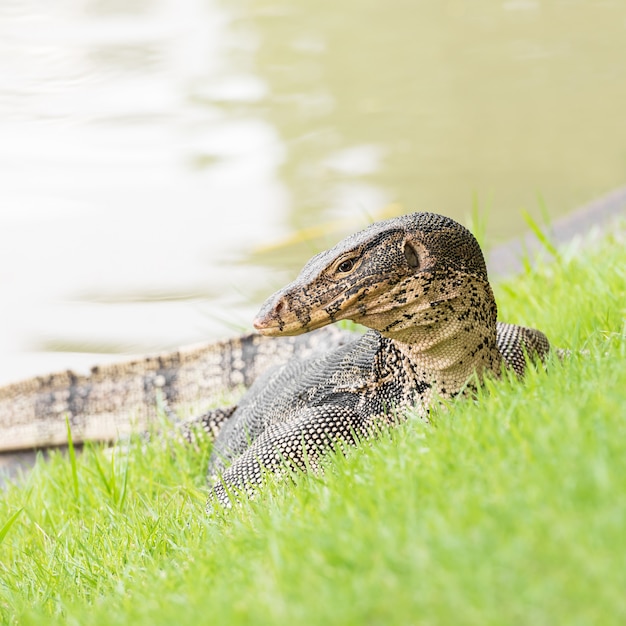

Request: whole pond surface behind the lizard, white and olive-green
left=0, top=0, right=626, bottom=382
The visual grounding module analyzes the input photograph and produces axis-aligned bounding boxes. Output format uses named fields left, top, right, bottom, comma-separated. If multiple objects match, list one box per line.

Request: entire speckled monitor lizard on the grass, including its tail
left=0, top=213, right=549, bottom=503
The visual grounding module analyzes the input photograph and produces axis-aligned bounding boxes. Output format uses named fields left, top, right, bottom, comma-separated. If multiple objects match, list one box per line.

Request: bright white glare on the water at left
left=0, top=2, right=286, bottom=379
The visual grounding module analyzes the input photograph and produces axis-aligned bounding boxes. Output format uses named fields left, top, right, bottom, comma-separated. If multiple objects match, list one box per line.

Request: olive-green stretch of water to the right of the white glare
left=242, top=0, right=626, bottom=236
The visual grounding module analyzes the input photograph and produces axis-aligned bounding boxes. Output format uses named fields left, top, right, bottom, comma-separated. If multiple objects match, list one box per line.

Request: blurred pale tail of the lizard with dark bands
left=0, top=328, right=349, bottom=451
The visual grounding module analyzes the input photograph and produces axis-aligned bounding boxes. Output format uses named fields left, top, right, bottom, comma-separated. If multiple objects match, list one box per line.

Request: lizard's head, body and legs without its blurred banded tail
left=197, top=213, right=549, bottom=504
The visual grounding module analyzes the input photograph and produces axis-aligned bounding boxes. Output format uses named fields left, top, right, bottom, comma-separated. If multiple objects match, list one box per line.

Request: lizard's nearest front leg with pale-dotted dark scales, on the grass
left=207, top=405, right=368, bottom=510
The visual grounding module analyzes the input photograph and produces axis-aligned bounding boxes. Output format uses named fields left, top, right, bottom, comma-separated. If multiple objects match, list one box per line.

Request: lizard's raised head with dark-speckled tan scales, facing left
left=254, top=213, right=495, bottom=341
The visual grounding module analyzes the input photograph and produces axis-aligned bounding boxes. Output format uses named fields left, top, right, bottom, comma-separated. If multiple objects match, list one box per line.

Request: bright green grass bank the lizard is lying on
left=0, top=222, right=626, bottom=626
